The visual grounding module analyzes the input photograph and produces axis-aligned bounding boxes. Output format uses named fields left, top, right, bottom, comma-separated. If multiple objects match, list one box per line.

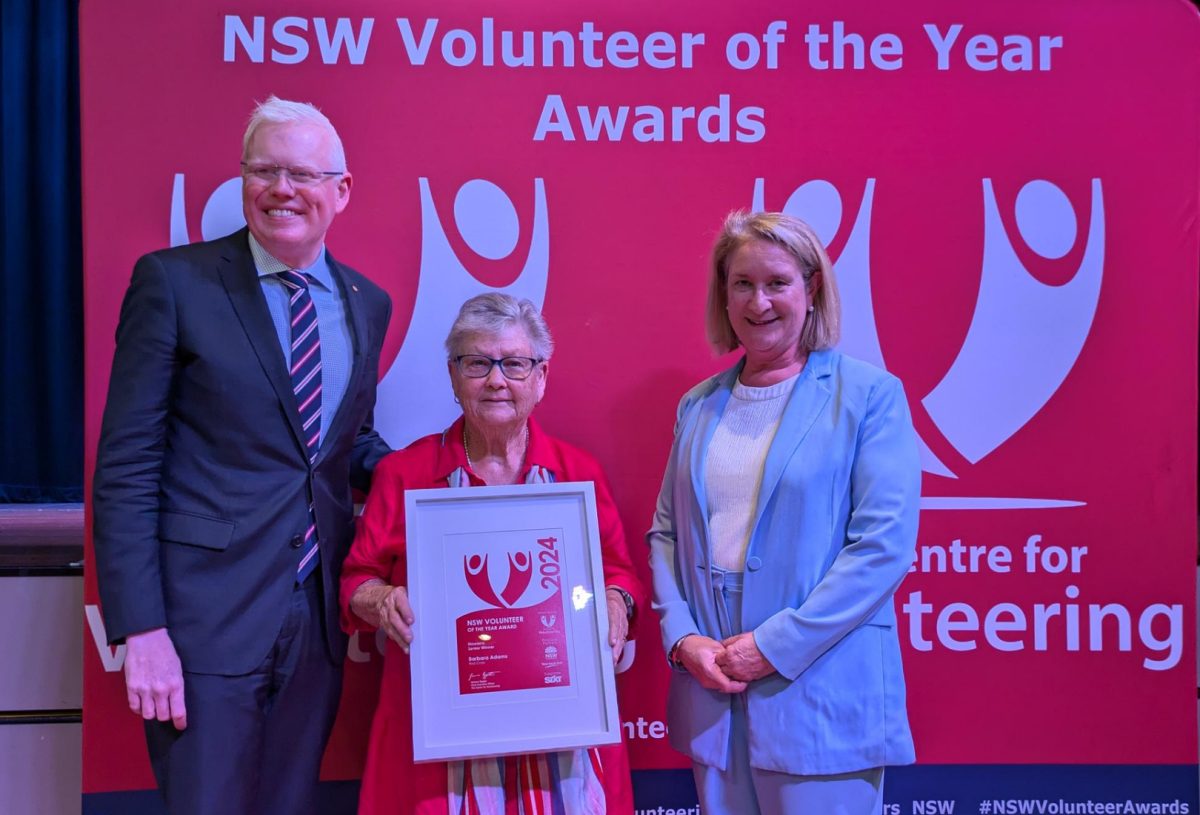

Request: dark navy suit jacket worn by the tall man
left=92, top=229, right=391, bottom=675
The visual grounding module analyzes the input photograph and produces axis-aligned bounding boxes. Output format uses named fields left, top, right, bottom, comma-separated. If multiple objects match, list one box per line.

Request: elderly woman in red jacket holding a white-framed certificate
left=342, top=294, right=642, bottom=815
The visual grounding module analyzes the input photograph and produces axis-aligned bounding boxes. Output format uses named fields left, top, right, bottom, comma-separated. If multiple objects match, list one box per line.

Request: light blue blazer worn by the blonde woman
left=647, top=350, right=920, bottom=775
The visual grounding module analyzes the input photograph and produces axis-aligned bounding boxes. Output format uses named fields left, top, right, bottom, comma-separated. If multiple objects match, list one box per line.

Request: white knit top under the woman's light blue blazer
left=704, top=374, right=799, bottom=571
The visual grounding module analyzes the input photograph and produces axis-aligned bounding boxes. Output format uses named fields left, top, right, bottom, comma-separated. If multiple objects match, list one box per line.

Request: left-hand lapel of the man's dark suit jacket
left=220, top=229, right=305, bottom=453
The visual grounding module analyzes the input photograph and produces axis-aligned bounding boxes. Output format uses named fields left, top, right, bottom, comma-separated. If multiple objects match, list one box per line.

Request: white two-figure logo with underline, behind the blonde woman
left=751, top=178, right=1104, bottom=509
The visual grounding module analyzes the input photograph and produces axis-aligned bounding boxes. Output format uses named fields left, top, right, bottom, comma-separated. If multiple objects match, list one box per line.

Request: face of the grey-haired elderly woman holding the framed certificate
left=450, top=325, right=547, bottom=437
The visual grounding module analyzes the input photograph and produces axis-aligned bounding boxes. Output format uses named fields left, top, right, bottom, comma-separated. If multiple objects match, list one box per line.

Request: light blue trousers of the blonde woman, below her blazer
left=692, top=567, right=883, bottom=815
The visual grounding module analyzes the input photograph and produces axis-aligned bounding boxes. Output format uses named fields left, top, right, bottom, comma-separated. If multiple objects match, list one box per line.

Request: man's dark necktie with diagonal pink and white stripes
left=280, top=270, right=320, bottom=583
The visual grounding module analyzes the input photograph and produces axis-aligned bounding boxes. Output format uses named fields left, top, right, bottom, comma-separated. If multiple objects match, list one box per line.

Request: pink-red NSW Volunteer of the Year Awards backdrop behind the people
left=80, top=0, right=1200, bottom=792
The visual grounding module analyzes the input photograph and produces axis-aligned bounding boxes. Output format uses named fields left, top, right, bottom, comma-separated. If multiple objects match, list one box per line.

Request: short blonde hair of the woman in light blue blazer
left=704, top=210, right=841, bottom=354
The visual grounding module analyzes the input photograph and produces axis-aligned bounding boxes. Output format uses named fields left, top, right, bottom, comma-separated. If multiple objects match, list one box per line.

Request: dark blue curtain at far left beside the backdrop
left=0, top=0, right=83, bottom=503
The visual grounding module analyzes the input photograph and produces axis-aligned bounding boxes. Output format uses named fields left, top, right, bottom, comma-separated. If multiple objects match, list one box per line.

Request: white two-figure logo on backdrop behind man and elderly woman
left=170, top=173, right=550, bottom=449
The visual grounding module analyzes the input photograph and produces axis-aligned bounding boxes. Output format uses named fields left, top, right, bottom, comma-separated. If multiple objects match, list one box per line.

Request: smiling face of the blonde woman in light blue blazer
left=725, top=240, right=821, bottom=364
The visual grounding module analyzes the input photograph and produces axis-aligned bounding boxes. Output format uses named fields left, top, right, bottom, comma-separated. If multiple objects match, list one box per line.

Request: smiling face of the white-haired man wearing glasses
left=241, top=122, right=353, bottom=269
